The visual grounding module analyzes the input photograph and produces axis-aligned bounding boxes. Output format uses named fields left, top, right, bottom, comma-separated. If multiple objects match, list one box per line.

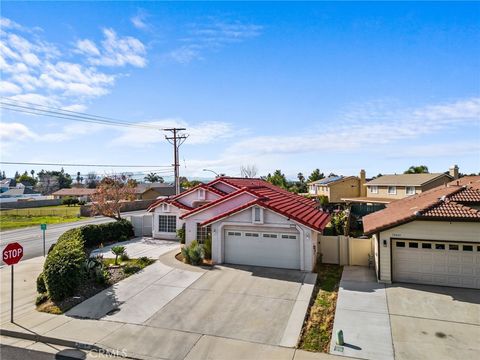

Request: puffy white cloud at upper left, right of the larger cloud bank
left=76, top=29, right=147, bottom=67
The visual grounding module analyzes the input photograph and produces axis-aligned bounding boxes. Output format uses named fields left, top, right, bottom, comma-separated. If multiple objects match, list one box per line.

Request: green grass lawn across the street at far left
left=0, top=205, right=84, bottom=231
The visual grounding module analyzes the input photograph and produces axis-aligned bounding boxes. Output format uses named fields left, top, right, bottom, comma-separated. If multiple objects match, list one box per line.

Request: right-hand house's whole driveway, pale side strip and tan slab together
left=330, top=266, right=480, bottom=360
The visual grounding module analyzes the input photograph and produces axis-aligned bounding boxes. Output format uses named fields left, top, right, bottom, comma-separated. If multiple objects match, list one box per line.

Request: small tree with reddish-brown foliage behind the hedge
left=92, top=176, right=135, bottom=220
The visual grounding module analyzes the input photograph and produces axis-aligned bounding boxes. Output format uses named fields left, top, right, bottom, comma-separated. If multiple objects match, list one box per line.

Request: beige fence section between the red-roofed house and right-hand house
left=318, top=235, right=373, bottom=266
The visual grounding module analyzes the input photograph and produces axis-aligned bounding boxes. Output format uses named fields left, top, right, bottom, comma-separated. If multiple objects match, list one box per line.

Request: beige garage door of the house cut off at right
left=392, top=240, right=480, bottom=289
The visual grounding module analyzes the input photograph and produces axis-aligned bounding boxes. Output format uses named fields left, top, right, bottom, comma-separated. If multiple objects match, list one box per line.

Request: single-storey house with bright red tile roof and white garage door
left=148, top=177, right=330, bottom=271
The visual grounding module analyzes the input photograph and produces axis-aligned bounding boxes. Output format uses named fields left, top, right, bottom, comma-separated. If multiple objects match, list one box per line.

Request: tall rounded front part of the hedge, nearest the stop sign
left=43, top=233, right=86, bottom=301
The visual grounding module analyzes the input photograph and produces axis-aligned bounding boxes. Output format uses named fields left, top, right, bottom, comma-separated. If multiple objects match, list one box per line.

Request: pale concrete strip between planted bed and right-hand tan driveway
left=330, top=266, right=394, bottom=360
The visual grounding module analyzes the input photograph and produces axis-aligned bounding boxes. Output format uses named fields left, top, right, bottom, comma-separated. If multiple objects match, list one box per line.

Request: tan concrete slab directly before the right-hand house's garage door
left=387, top=284, right=480, bottom=360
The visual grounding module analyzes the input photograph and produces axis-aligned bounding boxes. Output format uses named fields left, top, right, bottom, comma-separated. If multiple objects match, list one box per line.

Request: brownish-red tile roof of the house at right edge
left=363, top=185, right=480, bottom=234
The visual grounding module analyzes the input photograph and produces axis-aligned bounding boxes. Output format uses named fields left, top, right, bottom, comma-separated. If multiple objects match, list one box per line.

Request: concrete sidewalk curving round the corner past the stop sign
left=0, top=257, right=344, bottom=360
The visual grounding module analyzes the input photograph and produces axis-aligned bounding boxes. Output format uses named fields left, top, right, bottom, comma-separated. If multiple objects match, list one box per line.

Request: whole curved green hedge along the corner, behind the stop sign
left=37, top=220, right=134, bottom=301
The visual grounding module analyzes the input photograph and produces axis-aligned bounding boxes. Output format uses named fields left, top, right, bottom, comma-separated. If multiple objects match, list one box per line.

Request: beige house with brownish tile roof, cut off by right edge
left=363, top=176, right=480, bottom=289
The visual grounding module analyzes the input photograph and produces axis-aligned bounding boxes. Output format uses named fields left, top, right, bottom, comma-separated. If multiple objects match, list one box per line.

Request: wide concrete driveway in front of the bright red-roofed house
left=68, top=245, right=316, bottom=356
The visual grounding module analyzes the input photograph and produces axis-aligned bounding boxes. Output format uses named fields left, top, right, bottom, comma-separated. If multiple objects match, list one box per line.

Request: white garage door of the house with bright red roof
left=225, top=229, right=300, bottom=269
